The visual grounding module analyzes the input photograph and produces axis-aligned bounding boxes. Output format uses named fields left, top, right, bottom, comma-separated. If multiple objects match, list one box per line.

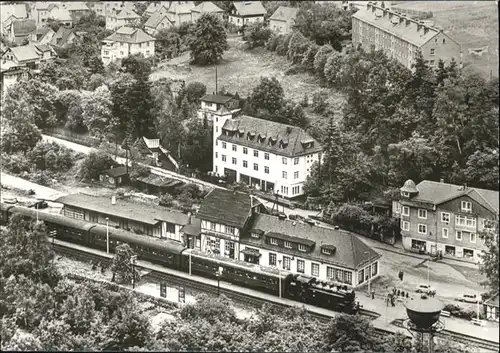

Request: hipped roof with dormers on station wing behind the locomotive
left=244, top=213, right=380, bottom=269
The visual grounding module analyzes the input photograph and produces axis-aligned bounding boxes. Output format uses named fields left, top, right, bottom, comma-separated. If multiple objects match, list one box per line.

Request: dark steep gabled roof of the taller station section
left=197, top=189, right=260, bottom=228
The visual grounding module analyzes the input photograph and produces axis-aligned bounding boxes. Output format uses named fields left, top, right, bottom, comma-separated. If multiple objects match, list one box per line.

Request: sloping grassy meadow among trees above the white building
left=151, top=37, right=344, bottom=128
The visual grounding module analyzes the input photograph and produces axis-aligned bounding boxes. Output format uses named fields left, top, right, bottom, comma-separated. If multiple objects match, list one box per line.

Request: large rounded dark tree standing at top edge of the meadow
left=189, top=14, right=229, bottom=65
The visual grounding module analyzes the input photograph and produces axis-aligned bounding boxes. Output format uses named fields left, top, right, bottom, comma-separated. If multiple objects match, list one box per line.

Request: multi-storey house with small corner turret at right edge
left=395, top=180, right=499, bottom=262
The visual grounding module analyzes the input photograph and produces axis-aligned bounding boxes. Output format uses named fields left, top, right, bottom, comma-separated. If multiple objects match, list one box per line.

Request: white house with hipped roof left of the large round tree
left=101, top=27, right=155, bottom=65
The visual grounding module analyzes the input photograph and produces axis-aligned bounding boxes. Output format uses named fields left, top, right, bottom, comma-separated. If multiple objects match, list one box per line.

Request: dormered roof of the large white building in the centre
left=218, top=115, right=322, bottom=157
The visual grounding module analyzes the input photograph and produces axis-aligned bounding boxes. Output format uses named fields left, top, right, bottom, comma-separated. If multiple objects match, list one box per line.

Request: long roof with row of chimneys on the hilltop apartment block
left=352, top=5, right=439, bottom=47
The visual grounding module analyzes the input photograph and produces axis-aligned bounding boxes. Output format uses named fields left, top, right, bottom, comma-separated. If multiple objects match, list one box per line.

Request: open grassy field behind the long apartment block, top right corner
left=394, top=1, right=499, bottom=77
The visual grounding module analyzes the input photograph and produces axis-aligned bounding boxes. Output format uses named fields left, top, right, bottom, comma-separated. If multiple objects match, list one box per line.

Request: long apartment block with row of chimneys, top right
left=352, top=2, right=462, bottom=70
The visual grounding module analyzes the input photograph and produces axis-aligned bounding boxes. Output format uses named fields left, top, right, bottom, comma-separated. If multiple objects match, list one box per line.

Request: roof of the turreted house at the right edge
left=411, top=180, right=499, bottom=213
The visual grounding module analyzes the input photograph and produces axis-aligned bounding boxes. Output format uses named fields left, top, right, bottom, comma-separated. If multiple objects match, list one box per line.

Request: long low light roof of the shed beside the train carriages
left=54, top=194, right=188, bottom=225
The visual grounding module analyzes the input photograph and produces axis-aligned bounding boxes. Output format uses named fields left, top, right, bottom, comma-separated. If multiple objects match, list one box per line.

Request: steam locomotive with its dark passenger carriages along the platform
left=0, top=203, right=359, bottom=314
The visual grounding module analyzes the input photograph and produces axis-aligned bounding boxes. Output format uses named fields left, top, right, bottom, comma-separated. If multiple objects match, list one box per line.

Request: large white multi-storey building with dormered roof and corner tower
left=213, top=109, right=322, bottom=198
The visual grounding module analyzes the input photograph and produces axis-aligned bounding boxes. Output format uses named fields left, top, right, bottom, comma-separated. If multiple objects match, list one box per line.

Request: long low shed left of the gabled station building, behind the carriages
left=54, top=194, right=190, bottom=242
